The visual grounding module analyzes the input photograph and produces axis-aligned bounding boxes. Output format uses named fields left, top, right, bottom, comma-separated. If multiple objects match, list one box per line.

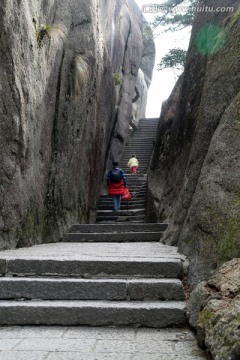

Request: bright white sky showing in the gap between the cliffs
left=135, top=0, right=190, bottom=118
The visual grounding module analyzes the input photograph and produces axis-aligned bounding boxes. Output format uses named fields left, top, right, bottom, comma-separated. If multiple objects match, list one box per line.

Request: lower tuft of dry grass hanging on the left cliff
left=70, top=55, right=89, bottom=100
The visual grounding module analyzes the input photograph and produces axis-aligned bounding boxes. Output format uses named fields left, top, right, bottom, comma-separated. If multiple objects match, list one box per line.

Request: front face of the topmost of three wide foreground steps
left=3, top=257, right=183, bottom=278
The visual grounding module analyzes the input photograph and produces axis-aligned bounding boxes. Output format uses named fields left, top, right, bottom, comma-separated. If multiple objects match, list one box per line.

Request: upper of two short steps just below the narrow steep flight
left=69, top=223, right=168, bottom=233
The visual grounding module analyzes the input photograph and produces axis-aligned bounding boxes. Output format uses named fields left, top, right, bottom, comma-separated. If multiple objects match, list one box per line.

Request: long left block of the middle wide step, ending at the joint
left=0, top=278, right=127, bottom=300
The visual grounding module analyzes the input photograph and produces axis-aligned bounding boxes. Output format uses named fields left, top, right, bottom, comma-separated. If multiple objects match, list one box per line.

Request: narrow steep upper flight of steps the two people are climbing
left=96, top=119, right=158, bottom=223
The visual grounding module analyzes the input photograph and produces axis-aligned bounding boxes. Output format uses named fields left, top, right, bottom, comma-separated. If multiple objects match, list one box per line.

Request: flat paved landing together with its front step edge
left=0, top=242, right=183, bottom=278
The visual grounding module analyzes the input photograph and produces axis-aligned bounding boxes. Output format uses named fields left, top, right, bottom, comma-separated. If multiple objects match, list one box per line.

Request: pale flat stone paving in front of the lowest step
left=0, top=326, right=206, bottom=360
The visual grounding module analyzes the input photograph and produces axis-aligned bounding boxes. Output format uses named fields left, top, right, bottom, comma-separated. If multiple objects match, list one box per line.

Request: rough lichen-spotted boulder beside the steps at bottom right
left=189, top=259, right=240, bottom=360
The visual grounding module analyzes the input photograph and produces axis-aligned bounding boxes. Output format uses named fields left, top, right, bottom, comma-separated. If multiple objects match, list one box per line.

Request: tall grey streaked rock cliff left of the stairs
left=0, top=0, right=154, bottom=249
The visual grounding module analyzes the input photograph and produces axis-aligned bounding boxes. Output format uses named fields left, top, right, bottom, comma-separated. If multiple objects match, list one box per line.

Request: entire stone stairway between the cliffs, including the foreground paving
left=0, top=120, right=205, bottom=360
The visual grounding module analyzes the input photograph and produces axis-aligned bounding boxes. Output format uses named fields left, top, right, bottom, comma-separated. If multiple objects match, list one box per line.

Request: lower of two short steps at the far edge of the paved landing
left=63, top=232, right=163, bottom=242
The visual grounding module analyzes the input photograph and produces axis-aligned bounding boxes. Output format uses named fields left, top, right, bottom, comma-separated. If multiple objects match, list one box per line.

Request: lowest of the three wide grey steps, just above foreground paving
left=0, top=300, right=187, bottom=328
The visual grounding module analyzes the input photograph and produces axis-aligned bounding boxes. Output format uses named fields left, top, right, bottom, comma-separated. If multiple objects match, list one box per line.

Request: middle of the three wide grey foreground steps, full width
left=0, top=278, right=184, bottom=301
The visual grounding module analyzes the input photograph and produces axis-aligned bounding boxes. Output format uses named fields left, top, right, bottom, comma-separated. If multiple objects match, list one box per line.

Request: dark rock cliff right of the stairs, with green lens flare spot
left=148, top=0, right=240, bottom=285
